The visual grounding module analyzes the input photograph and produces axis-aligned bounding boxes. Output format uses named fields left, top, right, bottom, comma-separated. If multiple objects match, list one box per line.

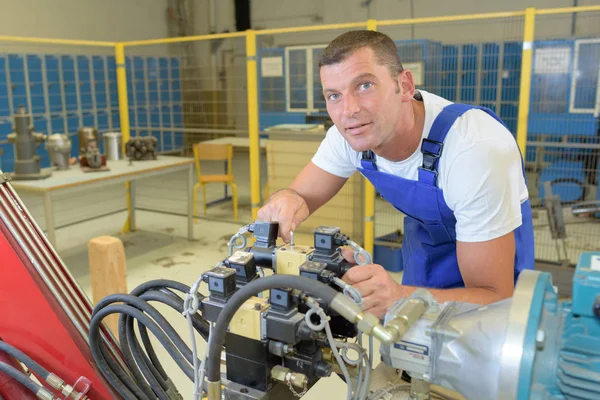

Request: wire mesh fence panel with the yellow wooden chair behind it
left=126, top=37, right=251, bottom=222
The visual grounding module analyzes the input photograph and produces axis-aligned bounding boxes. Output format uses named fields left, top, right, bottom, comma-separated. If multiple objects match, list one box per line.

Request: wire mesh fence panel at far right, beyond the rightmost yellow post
left=526, top=11, right=600, bottom=264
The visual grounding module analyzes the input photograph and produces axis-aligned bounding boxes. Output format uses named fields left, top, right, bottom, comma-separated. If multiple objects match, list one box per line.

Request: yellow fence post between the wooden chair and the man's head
left=246, top=29, right=260, bottom=221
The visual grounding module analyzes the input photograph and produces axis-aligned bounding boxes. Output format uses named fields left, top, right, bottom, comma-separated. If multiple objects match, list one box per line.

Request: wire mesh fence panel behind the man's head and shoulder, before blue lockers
left=375, top=16, right=524, bottom=255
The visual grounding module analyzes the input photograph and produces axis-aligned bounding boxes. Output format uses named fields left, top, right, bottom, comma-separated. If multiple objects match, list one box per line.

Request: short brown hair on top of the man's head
left=319, top=30, right=404, bottom=77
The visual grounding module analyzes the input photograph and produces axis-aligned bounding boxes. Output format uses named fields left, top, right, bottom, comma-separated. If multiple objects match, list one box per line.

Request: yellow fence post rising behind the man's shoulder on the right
left=517, top=7, right=535, bottom=158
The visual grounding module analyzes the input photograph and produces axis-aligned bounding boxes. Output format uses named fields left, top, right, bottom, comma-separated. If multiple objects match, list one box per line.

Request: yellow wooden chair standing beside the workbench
left=193, top=142, right=238, bottom=221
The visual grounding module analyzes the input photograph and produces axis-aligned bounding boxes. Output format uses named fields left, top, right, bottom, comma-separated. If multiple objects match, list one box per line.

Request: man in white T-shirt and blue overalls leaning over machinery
left=258, top=31, right=534, bottom=317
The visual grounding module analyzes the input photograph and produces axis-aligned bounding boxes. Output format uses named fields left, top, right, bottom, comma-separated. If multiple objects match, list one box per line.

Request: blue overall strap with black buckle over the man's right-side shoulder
left=419, top=103, right=506, bottom=186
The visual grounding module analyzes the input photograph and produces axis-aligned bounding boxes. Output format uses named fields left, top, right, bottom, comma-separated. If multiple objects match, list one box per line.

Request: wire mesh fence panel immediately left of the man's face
left=257, top=29, right=364, bottom=241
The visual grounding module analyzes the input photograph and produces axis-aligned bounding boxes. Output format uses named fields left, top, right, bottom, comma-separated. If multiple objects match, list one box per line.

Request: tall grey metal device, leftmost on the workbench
left=8, top=106, right=52, bottom=180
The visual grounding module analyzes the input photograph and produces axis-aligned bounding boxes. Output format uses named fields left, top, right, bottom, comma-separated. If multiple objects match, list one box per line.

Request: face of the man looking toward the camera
left=321, top=47, right=403, bottom=151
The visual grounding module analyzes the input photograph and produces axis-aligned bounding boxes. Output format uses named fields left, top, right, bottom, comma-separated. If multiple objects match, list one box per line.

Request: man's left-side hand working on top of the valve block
left=258, top=189, right=310, bottom=243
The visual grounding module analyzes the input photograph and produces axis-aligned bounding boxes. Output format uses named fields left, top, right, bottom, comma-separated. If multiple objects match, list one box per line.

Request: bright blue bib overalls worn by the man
left=358, top=104, right=534, bottom=288
